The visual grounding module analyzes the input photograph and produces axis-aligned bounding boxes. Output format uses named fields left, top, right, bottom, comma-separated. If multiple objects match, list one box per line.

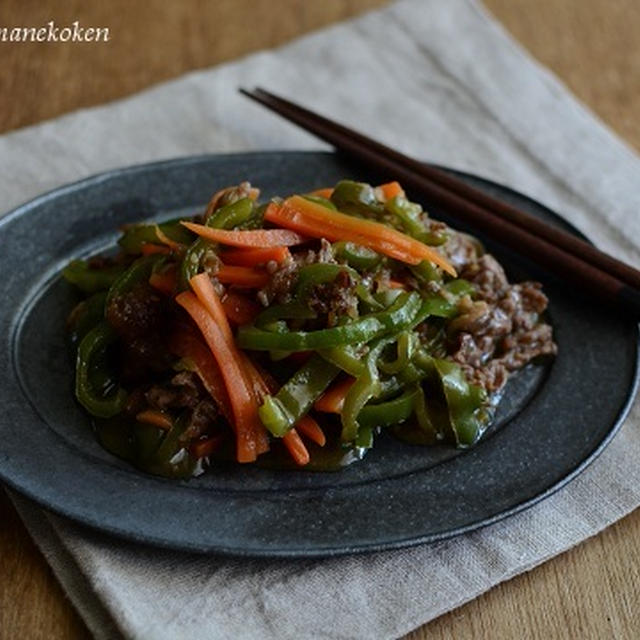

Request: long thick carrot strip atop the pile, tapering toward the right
left=264, top=196, right=456, bottom=276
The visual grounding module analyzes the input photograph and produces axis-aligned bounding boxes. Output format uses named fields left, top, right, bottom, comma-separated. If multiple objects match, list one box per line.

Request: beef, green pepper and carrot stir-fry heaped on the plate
left=63, top=180, right=556, bottom=477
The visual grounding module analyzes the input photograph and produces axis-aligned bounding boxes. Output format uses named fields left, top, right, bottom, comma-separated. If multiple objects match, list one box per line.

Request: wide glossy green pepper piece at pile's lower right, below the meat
left=433, top=358, right=489, bottom=447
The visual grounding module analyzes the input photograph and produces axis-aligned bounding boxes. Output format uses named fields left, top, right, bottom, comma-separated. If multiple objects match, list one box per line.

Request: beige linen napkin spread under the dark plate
left=0, top=0, right=640, bottom=639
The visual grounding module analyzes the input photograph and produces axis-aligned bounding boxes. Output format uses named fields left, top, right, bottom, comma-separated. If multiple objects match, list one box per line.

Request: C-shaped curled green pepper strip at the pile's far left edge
left=75, top=321, right=127, bottom=418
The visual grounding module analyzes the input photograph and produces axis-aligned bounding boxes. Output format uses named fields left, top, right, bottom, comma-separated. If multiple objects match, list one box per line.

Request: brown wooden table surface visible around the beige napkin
left=0, top=0, right=640, bottom=640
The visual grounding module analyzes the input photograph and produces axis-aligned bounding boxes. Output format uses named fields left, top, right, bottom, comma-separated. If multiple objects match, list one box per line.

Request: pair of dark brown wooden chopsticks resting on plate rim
left=240, top=89, right=640, bottom=315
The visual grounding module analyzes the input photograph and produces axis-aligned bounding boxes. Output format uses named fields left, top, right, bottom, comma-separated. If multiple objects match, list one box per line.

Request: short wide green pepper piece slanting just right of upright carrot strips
left=258, top=355, right=340, bottom=438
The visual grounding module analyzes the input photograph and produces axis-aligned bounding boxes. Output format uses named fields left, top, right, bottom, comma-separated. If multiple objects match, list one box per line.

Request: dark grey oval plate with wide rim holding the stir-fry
left=0, top=153, right=638, bottom=556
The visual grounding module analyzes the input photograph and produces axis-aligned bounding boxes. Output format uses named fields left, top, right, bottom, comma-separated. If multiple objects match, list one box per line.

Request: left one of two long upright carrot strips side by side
left=176, top=291, right=257, bottom=462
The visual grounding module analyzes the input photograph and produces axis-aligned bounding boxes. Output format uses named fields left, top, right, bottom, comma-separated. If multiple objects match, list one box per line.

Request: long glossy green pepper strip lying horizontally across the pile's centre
left=236, top=292, right=422, bottom=351
